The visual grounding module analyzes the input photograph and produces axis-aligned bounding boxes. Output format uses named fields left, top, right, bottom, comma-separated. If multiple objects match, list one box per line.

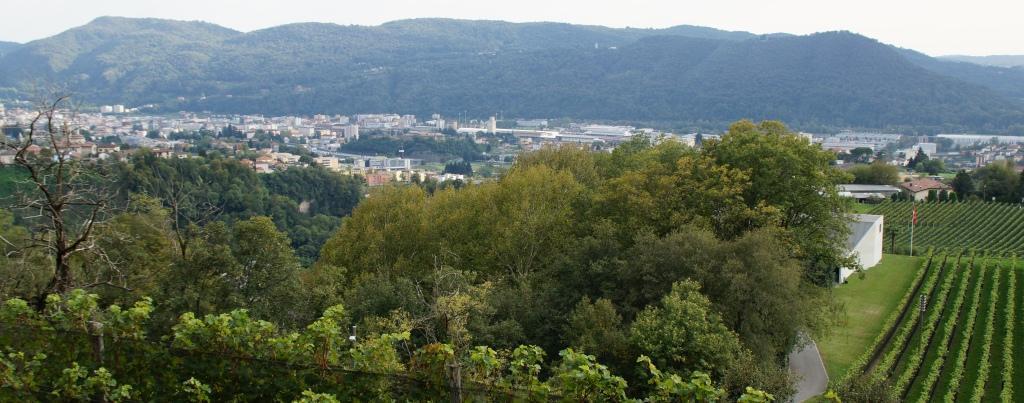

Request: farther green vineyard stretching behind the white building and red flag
left=868, top=202, right=1024, bottom=257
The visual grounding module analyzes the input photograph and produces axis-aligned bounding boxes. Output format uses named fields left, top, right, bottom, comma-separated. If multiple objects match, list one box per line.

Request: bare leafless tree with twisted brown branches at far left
left=0, top=95, right=116, bottom=305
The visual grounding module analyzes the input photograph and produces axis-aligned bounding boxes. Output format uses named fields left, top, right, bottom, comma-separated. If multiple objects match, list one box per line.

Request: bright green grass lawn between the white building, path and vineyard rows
left=817, top=255, right=923, bottom=378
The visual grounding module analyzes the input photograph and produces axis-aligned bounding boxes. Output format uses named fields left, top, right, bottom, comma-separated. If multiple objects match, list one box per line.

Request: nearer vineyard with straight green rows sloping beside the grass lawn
left=838, top=250, right=1024, bottom=402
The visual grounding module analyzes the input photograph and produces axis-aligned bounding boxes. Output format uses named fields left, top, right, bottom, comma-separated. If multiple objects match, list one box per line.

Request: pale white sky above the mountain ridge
left=0, top=0, right=1024, bottom=55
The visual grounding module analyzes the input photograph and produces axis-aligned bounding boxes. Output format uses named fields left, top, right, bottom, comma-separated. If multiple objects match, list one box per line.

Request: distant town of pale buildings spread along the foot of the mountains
left=0, top=104, right=1024, bottom=186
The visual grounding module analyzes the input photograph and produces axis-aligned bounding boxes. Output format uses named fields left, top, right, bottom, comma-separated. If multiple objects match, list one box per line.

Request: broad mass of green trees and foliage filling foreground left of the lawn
left=0, top=109, right=864, bottom=400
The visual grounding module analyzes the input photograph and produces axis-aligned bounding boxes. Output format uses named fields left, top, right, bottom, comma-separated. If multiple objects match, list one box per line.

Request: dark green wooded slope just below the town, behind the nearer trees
left=119, top=153, right=365, bottom=264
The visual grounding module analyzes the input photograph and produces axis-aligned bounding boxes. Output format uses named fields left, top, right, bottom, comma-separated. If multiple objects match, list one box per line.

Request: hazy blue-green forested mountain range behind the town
left=0, top=17, right=1024, bottom=133
